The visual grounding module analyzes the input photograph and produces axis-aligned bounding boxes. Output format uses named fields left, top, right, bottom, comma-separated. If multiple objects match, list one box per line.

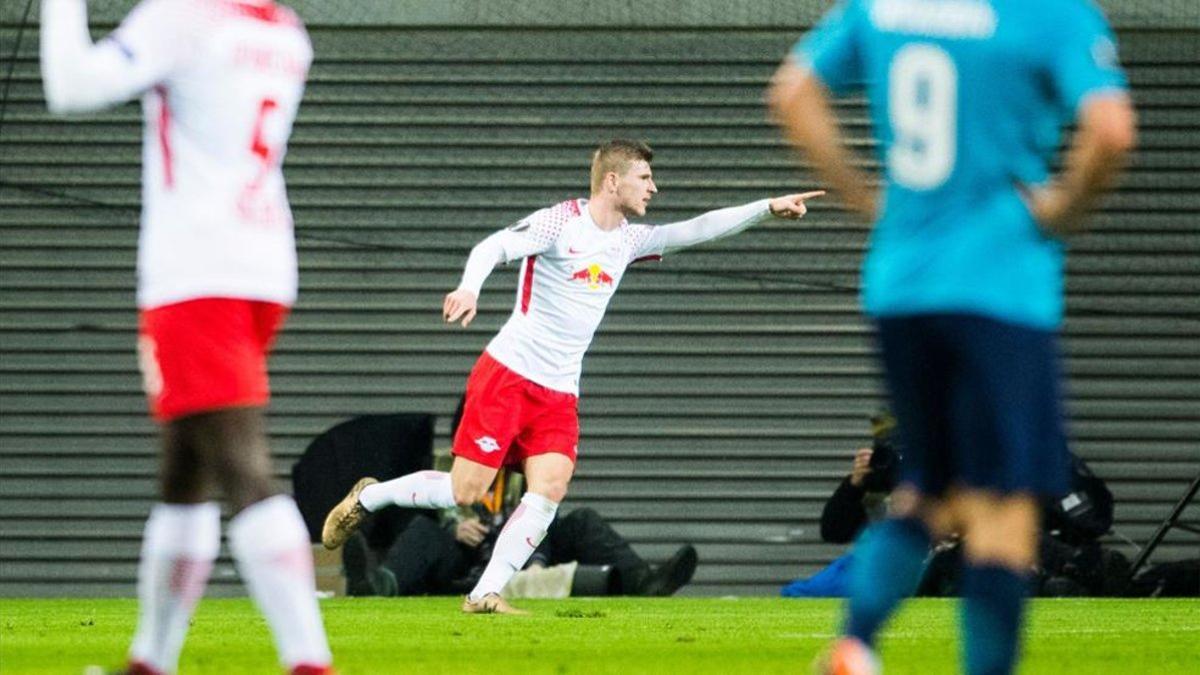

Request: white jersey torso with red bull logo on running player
left=487, top=199, right=664, bottom=395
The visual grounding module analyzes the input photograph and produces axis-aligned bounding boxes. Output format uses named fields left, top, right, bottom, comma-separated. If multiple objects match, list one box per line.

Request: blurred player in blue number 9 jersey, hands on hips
left=769, top=0, right=1135, bottom=674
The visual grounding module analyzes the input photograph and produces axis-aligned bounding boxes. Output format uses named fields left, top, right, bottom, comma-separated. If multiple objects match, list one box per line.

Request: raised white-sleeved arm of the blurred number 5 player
left=41, top=0, right=190, bottom=114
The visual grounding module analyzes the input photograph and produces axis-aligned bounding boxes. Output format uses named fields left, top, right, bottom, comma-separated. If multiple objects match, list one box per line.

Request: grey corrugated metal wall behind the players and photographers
left=0, top=1, right=1200, bottom=596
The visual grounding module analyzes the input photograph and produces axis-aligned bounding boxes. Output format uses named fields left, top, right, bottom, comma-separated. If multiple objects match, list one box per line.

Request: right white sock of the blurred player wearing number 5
left=229, top=495, right=332, bottom=669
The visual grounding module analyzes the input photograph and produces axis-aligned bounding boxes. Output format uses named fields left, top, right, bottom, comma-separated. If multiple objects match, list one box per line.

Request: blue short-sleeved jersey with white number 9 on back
left=796, top=0, right=1127, bottom=329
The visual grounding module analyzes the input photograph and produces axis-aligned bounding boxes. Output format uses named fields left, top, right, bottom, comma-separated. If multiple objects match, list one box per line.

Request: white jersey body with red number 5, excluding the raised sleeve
left=109, top=0, right=312, bottom=307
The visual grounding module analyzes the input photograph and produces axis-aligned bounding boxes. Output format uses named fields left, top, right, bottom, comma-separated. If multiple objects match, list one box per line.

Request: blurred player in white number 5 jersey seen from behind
left=41, top=0, right=332, bottom=674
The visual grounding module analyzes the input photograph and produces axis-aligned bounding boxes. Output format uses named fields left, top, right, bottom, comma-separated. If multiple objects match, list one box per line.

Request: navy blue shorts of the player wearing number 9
left=877, top=313, right=1068, bottom=496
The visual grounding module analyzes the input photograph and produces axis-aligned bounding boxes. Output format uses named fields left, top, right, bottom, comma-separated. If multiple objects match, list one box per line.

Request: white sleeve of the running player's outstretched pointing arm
left=628, top=199, right=772, bottom=262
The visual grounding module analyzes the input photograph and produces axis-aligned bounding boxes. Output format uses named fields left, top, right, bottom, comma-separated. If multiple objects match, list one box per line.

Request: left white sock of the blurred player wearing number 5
left=130, top=503, right=221, bottom=673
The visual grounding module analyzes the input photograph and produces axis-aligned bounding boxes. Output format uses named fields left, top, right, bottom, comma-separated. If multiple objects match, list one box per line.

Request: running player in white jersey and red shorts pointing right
left=323, top=139, right=823, bottom=614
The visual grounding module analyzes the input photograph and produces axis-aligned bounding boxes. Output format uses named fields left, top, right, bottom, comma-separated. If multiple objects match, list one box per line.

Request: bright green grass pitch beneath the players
left=0, top=598, right=1200, bottom=675
